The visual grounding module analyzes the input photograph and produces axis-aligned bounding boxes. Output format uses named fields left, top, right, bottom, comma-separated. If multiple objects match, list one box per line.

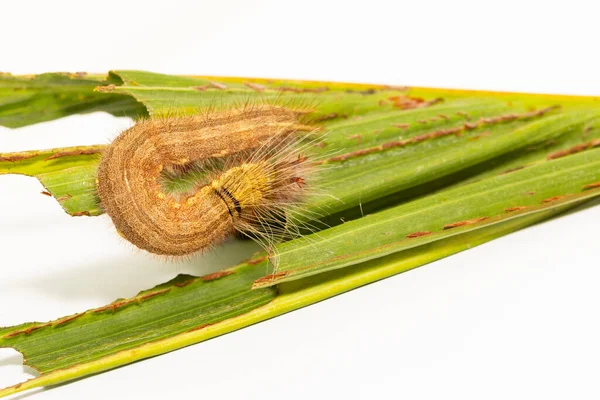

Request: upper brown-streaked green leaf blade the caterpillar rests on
left=0, top=71, right=600, bottom=225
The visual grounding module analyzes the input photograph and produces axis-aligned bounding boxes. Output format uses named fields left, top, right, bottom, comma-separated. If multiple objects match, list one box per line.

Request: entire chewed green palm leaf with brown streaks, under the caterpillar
left=0, top=71, right=600, bottom=397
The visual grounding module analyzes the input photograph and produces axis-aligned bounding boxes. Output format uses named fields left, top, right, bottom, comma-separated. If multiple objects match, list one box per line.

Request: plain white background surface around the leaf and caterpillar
left=0, top=0, right=600, bottom=400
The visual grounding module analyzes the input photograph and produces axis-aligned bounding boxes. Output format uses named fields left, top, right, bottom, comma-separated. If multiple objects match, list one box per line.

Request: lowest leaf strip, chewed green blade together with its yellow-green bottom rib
left=0, top=199, right=570, bottom=397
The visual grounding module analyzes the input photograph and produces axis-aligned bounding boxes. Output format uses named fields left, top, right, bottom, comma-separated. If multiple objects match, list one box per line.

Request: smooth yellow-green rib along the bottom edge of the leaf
left=0, top=200, right=584, bottom=397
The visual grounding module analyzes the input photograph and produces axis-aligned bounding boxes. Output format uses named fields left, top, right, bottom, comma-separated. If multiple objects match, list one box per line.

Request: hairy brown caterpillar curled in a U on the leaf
left=97, top=106, right=314, bottom=256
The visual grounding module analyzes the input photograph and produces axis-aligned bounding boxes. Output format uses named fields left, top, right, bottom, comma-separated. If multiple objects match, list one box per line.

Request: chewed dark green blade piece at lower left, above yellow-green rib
left=0, top=265, right=276, bottom=373
